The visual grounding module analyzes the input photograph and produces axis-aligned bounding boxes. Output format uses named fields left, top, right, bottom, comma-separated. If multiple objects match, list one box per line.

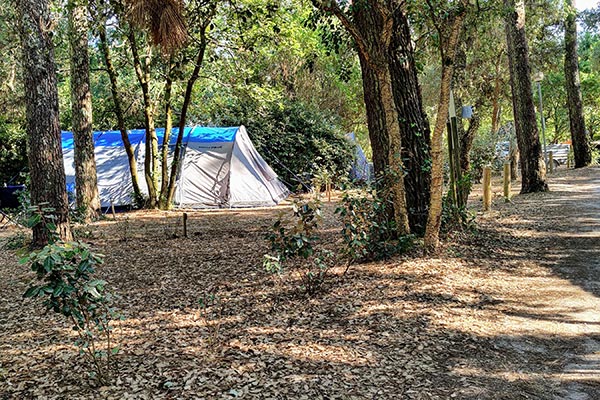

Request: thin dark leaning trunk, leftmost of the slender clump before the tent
left=97, top=18, right=143, bottom=202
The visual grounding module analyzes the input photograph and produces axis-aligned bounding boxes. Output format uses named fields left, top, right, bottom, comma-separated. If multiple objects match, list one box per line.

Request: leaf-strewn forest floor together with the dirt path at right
left=0, top=168, right=600, bottom=400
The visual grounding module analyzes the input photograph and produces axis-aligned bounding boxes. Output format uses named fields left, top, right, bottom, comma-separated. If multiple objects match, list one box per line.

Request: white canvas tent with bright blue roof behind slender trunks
left=63, top=126, right=289, bottom=208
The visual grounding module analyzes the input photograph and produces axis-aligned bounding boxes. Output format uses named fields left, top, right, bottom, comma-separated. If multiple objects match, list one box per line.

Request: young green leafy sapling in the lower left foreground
left=20, top=207, right=119, bottom=385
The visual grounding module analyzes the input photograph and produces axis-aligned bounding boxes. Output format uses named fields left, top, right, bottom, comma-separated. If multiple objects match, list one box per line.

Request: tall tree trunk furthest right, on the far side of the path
left=565, top=0, right=592, bottom=168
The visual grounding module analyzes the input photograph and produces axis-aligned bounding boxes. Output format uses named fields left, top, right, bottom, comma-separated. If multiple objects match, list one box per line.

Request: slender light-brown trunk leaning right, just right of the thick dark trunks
left=425, top=12, right=465, bottom=251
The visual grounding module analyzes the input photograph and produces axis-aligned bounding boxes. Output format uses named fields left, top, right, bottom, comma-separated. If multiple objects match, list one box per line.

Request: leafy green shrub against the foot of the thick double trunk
left=335, top=177, right=412, bottom=265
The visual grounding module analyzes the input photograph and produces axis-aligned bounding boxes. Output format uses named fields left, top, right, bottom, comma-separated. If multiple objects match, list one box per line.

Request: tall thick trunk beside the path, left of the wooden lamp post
left=504, top=0, right=548, bottom=193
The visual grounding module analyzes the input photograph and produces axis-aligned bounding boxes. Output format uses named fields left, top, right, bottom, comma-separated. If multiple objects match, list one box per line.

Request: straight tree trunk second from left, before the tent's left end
left=68, top=0, right=100, bottom=222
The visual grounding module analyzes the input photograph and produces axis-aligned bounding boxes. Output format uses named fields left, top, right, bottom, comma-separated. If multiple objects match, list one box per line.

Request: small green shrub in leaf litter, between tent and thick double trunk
left=263, top=200, right=333, bottom=296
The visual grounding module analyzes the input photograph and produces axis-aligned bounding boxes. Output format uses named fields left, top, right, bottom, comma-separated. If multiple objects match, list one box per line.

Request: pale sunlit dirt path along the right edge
left=476, top=168, right=600, bottom=400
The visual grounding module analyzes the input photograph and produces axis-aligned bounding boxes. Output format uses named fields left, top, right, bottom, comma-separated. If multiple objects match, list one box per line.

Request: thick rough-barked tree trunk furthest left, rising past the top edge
left=16, top=0, right=72, bottom=246
